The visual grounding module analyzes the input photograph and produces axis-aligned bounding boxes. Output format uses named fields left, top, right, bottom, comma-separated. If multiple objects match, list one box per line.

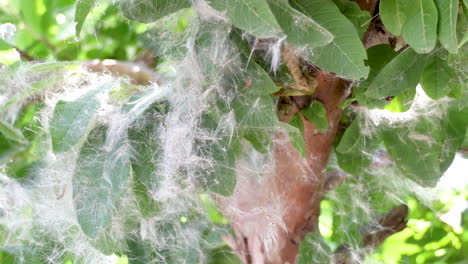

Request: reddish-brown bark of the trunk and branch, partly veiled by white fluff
left=219, top=0, right=414, bottom=264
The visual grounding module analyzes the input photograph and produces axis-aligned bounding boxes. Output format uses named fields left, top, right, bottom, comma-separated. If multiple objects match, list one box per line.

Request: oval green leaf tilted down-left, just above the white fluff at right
left=366, top=49, right=427, bottom=98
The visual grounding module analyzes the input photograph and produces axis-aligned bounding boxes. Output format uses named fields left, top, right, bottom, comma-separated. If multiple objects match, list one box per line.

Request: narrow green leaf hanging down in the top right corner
left=435, top=0, right=458, bottom=54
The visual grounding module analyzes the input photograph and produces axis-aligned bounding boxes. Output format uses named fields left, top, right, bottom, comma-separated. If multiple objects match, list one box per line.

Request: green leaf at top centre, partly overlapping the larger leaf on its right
left=268, top=0, right=333, bottom=47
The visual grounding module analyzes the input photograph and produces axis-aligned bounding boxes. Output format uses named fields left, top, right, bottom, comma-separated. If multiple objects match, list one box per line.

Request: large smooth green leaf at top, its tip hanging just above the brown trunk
left=290, top=0, right=369, bottom=80
